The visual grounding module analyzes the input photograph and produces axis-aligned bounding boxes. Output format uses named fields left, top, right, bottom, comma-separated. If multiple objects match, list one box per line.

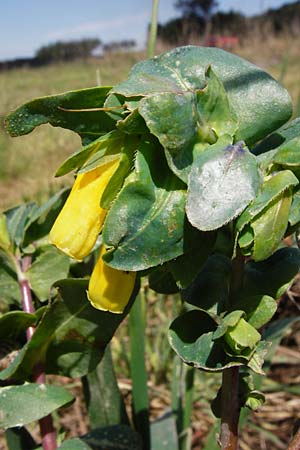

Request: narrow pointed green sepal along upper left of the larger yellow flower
left=55, top=130, right=122, bottom=177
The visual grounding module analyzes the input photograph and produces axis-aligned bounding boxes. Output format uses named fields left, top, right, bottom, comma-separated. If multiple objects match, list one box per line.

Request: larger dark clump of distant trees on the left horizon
left=35, top=39, right=101, bottom=64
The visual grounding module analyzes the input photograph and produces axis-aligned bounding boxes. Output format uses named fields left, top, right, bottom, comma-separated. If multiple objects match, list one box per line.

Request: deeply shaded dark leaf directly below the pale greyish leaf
left=168, top=225, right=216, bottom=289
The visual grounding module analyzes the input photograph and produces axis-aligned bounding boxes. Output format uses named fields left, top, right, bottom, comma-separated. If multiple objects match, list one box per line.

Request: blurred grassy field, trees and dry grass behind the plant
left=0, top=0, right=300, bottom=450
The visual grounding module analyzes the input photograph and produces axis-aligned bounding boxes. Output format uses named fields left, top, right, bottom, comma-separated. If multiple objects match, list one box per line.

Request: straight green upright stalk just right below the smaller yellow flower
left=129, top=294, right=150, bottom=450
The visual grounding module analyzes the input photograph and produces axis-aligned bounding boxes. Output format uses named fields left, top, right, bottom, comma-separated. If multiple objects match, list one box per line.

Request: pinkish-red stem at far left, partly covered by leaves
left=18, top=256, right=57, bottom=450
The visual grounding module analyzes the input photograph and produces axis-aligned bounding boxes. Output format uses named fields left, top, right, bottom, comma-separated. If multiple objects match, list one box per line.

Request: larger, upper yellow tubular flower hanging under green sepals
left=49, top=160, right=119, bottom=261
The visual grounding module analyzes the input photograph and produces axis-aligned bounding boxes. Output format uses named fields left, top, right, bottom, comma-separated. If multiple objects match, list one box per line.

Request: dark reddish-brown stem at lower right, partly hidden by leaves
left=220, top=249, right=245, bottom=450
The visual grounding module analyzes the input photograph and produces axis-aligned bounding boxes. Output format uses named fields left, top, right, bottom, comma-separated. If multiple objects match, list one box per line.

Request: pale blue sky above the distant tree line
left=0, top=0, right=291, bottom=61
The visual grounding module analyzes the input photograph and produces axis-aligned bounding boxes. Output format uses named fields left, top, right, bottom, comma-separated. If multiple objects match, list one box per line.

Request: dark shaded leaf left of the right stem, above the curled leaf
left=181, top=254, right=231, bottom=313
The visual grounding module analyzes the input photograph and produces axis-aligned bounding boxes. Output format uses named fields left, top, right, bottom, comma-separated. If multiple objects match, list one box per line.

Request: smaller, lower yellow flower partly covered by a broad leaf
left=88, top=246, right=136, bottom=314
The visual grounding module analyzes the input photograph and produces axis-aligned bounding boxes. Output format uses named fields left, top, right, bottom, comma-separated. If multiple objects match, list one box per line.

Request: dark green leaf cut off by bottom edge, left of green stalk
left=81, top=425, right=143, bottom=450
